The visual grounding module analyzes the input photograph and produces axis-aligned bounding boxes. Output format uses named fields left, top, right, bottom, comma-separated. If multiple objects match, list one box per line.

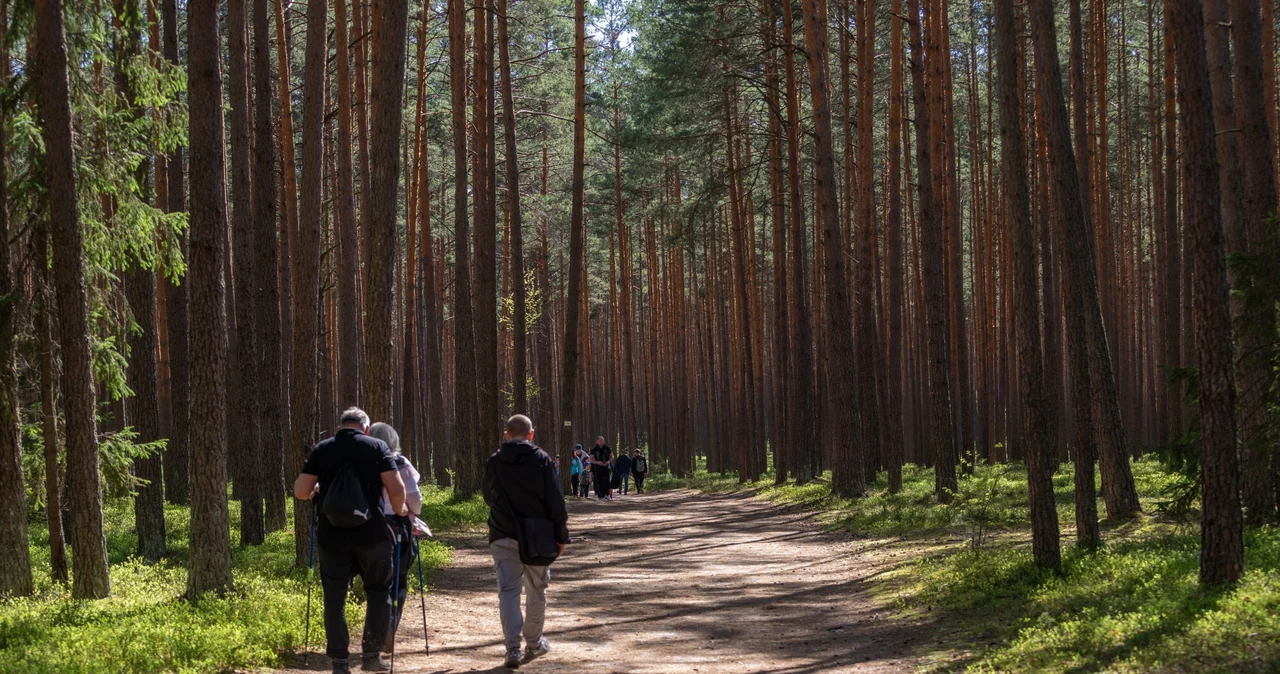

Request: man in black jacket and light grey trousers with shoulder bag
left=483, top=414, right=568, bottom=669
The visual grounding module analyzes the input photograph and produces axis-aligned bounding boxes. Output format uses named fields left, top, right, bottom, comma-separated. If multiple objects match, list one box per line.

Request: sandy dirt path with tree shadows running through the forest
left=285, top=491, right=927, bottom=674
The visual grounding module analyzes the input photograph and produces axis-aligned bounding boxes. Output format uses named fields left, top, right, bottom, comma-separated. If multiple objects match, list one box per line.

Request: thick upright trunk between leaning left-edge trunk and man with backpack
left=187, top=0, right=232, bottom=599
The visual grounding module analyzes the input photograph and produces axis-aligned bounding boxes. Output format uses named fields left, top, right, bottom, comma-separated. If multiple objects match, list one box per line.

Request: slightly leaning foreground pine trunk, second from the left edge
left=36, top=0, right=111, bottom=599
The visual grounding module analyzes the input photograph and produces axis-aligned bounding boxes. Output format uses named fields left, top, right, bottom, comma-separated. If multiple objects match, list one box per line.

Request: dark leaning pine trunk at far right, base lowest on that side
left=1169, top=0, right=1244, bottom=586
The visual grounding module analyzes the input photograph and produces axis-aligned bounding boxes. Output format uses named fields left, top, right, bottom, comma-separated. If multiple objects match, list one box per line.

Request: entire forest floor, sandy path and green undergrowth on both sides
left=0, top=460, right=1280, bottom=674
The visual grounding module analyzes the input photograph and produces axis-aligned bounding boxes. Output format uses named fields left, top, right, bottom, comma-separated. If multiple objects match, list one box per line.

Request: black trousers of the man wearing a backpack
left=320, top=538, right=394, bottom=662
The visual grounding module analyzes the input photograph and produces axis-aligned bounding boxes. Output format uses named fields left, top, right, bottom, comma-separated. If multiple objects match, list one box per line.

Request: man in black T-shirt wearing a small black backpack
left=293, top=407, right=408, bottom=674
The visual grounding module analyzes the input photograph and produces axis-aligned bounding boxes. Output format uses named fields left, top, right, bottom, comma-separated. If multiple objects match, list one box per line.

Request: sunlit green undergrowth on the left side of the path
left=0, top=487, right=488, bottom=674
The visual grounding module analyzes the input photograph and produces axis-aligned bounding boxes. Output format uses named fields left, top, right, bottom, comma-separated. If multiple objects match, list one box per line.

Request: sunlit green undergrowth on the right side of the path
left=652, top=459, right=1280, bottom=673
